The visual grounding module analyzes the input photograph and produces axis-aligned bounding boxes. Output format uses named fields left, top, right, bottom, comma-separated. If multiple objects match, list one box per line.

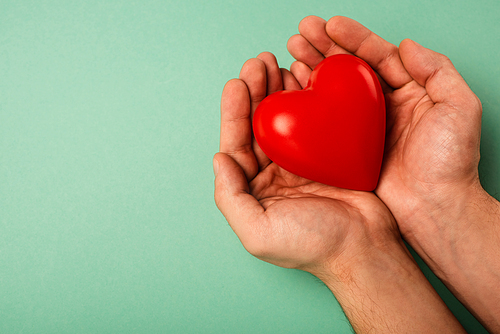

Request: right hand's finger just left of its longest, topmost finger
left=299, top=16, right=350, bottom=58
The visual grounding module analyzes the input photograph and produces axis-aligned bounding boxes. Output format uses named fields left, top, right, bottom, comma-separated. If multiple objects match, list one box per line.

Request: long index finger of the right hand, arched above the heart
left=326, top=16, right=412, bottom=88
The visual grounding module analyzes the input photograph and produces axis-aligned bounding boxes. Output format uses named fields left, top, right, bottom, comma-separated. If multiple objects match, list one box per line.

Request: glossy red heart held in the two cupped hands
left=253, top=54, right=385, bottom=191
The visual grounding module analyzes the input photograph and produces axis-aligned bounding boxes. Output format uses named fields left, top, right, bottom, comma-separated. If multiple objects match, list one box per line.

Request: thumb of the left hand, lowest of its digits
left=214, top=153, right=266, bottom=253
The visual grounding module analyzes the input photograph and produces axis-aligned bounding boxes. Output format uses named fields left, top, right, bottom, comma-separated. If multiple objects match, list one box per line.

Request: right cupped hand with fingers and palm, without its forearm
left=288, top=16, right=481, bottom=239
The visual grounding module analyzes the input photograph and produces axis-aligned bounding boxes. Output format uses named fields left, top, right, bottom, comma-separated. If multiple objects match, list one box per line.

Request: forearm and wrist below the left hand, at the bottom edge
left=312, top=240, right=463, bottom=333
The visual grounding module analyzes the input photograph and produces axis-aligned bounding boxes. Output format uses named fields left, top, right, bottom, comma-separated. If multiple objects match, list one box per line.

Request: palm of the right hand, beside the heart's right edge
left=376, top=78, right=479, bottom=220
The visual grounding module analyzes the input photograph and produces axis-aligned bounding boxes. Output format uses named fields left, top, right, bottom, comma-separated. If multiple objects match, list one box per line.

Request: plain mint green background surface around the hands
left=0, top=0, right=500, bottom=333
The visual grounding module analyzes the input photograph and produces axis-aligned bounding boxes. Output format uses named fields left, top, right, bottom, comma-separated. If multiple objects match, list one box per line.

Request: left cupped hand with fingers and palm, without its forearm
left=214, top=53, right=400, bottom=276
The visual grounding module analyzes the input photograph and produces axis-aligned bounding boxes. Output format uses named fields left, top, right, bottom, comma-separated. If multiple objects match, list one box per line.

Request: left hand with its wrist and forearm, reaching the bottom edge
left=214, top=53, right=463, bottom=333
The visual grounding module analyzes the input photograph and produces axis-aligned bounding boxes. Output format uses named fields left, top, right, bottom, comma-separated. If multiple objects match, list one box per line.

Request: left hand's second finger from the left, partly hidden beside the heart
left=240, top=58, right=271, bottom=172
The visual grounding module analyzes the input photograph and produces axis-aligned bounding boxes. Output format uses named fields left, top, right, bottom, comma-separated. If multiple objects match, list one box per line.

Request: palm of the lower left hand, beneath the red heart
left=243, top=163, right=396, bottom=269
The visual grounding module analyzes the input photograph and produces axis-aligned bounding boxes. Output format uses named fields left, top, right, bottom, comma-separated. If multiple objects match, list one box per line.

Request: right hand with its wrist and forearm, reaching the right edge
left=288, top=16, right=500, bottom=333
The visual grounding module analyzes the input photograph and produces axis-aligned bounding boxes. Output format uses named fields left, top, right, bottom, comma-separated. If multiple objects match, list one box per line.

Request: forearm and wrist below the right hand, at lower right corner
left=405, top=183, right=500, bottom=332
